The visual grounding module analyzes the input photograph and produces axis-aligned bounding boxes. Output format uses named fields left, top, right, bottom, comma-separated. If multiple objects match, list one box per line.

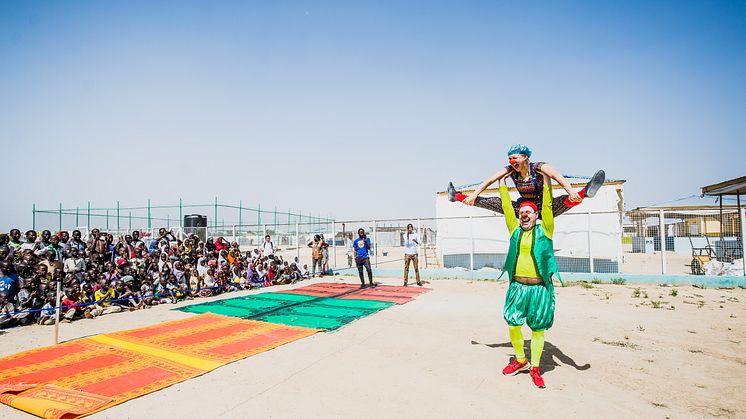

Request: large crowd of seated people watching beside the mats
left=0, top=228, right=309, bottom=328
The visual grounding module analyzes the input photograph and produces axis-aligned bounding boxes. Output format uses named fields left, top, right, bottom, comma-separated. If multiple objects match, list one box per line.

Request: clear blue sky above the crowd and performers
left=0, top=1, right=746, bottom=230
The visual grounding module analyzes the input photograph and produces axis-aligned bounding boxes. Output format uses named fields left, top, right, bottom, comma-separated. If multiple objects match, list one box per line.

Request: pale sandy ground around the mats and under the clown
left=0, top=277, right=746, bottom=419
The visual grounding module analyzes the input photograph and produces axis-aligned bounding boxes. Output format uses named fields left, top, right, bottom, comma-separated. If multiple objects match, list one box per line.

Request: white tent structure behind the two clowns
left=435, top=178, right=624, bottom=273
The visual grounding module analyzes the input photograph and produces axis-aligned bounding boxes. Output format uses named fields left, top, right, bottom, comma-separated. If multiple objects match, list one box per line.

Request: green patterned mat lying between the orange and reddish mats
left=175, top=292, right=394, bottom=330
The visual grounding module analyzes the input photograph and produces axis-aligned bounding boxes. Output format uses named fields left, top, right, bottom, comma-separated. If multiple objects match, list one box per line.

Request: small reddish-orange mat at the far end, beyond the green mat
left=280, top=282, right=430, bottom=304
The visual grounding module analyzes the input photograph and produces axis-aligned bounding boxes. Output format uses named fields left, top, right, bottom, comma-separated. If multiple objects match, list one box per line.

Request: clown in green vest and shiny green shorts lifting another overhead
left=500, top=169, right=562, bottom=388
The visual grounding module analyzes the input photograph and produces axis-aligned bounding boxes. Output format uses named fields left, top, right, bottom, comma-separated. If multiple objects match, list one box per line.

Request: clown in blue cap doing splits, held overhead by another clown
left=448, top=144, right=606, bottom=217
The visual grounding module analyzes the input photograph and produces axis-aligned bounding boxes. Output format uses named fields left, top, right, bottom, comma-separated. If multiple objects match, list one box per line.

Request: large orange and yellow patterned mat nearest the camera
left=0, top=313, right=318, bottom=418
